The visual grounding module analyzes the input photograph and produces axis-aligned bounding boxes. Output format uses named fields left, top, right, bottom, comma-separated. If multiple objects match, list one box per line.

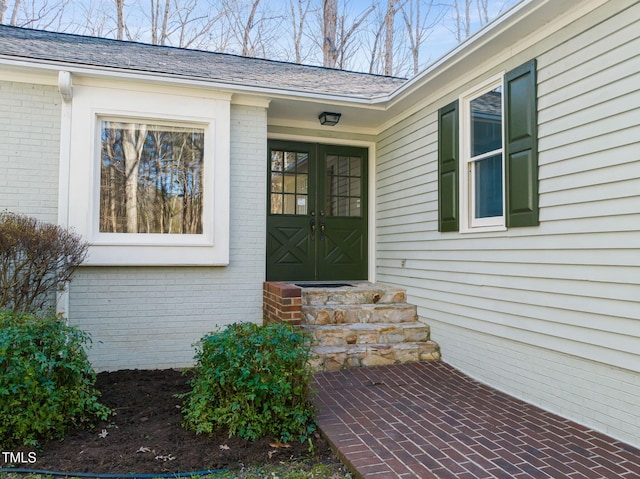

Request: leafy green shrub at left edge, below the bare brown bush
left=0, top=312, right=110, bottom=450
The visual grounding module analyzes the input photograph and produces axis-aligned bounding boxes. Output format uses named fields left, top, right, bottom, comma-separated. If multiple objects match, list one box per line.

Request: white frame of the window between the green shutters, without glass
left=458, top=72, right=507, bottom=233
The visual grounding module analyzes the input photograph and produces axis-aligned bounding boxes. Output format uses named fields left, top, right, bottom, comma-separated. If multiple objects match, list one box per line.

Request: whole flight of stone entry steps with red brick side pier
left=264, top=282, right=440, bottom=371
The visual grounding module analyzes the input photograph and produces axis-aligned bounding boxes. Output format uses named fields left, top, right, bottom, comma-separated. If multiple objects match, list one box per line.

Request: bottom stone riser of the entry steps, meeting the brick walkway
left=311, top=341, right=440, bottom=371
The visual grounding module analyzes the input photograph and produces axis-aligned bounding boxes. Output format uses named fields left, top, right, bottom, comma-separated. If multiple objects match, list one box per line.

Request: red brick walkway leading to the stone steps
left=314, top=362, right=640, bottom=479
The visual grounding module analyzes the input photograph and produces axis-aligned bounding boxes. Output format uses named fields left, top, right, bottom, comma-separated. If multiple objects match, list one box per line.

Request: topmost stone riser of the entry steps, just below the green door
left=302, top=288, right=407, bottom=306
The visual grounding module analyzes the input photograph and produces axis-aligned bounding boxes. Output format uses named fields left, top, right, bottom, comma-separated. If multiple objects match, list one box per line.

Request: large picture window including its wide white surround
left=66, top=83, right=231, bottom=266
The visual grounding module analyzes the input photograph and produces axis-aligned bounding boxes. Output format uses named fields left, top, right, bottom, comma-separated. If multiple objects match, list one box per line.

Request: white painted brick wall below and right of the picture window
left=69, top=105, right=267, bottom=371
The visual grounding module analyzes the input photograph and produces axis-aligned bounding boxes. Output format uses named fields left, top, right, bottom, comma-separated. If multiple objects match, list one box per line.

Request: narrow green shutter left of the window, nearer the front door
left=438, top=100, right=459, bottom=231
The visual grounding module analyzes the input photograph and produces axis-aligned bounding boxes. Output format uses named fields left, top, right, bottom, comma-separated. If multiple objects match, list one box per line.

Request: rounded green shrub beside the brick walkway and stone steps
left=183, top=323, right=315, bottom=442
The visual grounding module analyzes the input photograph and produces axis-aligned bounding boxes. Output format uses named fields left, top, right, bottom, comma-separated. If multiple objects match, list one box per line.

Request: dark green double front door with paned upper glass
left=267, top=141, right=367, bottom=281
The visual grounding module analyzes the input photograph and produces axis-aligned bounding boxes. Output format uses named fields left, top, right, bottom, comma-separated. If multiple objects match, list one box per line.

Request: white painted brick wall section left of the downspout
left=0, top=81, right=62, bottom=223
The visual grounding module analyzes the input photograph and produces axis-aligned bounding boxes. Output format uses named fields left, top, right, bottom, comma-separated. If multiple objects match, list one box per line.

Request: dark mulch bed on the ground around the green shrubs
left=32, top=370, right=336, bottom=474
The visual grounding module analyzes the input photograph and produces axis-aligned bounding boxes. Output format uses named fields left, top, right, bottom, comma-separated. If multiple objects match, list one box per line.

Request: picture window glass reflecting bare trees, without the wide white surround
left=99, top=119, right=205, bottom=234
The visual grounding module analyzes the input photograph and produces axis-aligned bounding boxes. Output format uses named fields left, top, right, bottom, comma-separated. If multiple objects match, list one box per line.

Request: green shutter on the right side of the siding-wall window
left=504, top=59, right=538, bottom=228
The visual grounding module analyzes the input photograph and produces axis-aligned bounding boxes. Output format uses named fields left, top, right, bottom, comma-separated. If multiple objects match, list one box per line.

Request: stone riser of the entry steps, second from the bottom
left=303, top=323, right=429, bottom=346
